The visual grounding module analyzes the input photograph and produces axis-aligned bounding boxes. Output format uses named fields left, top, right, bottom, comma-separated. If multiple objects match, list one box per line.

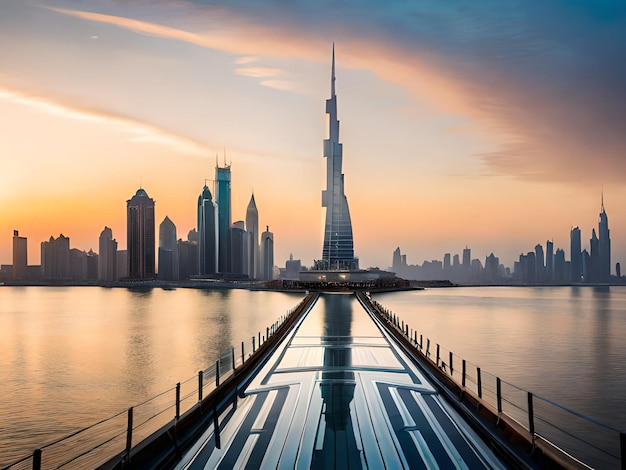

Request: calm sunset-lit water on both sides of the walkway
left=0, top=286, right=626, bottom=465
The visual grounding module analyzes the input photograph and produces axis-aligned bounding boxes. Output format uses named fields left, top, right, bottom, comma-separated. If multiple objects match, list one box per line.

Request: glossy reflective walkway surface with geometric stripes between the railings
left=177, top=294, right=504, bottom=469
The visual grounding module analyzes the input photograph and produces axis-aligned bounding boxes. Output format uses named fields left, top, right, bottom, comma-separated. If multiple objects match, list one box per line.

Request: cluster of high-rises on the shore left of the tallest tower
left=0, top=164, right=274, bottom=283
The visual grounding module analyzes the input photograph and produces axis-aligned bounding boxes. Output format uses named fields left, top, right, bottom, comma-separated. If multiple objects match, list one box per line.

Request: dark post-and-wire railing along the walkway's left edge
left=2, top=299, right=306, bottom=470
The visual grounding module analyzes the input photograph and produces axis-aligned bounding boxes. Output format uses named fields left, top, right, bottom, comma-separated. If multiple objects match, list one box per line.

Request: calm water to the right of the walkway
left=374, top=286, right=626, bottom=429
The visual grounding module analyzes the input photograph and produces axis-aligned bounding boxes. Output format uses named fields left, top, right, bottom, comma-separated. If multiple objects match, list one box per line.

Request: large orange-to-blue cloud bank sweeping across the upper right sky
left=45, top=0, right=626, bottom=182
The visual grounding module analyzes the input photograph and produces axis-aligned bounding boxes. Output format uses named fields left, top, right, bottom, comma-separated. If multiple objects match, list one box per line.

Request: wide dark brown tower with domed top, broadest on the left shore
left=126, top=188, right=156, bottom=280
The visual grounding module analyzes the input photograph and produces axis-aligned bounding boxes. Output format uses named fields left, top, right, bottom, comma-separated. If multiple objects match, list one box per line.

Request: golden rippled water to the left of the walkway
left=0, top=286, right=302, bottom=466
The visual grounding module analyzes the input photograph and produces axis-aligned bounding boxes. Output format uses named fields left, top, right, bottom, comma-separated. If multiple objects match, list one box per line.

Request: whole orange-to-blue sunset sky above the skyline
left=0, top=0, right=626, bottom=271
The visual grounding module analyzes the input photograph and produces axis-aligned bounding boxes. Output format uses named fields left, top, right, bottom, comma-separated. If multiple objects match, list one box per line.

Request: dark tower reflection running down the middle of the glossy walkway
left=311, top=294, right=360, bottom=468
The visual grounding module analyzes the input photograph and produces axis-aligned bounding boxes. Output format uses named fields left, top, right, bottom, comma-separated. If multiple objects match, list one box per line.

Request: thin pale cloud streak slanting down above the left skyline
left=0, top=85, right=208, bottom=156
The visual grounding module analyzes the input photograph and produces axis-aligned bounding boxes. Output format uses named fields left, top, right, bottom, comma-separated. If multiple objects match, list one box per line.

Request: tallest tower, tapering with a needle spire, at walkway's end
left=322, top=44, right=359, bottom=269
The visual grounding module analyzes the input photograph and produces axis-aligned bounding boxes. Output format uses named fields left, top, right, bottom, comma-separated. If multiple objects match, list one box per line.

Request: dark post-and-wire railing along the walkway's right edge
left=365, top=296, right=626, bottom=469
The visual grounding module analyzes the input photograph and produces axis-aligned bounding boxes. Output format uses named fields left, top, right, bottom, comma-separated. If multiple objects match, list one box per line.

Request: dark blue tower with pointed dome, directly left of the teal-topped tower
left=198, top=184, right=218, bottom=276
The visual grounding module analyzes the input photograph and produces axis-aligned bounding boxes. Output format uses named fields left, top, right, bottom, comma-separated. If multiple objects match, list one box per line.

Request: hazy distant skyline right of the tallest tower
left=391, top=200, right=621, bottom=285
